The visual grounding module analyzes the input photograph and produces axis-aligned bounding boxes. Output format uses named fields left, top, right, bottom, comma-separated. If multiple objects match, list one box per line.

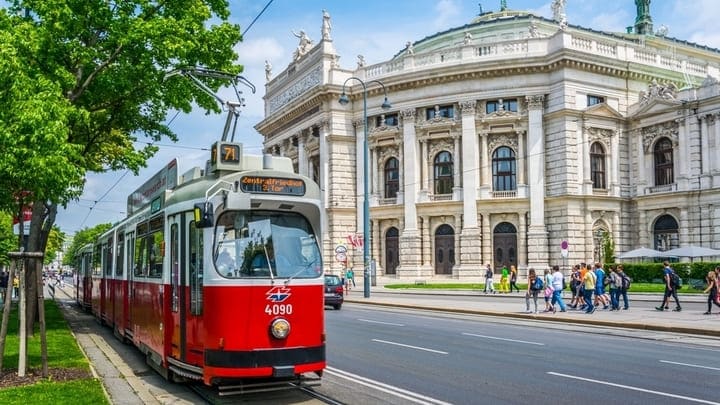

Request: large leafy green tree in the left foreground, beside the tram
left=0, top=0, right=242, bottom=333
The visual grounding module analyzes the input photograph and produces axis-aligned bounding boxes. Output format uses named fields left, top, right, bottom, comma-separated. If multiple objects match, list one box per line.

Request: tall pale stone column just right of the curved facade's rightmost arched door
left=527, top=94, right=548, bottom=269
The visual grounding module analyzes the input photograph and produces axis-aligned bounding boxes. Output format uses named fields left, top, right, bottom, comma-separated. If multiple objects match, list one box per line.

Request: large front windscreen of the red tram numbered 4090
left=213, top=211, right=322, bottom=278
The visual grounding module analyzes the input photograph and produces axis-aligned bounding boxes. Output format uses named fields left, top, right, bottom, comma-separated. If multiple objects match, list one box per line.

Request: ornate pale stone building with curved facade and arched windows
left=256, top=4, right=720, bottom=279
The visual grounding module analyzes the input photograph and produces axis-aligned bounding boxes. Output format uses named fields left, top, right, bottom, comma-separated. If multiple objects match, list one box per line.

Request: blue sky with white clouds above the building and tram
left=53, top=0, right=720, bottom=236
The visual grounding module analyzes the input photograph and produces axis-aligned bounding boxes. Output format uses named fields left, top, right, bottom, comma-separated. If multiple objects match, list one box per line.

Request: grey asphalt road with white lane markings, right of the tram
left=322, top=303, right=720, bottom=404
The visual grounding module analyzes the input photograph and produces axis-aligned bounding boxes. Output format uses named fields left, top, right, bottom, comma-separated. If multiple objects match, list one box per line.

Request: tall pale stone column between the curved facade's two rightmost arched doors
left=455, top=100, right=482, bottom=277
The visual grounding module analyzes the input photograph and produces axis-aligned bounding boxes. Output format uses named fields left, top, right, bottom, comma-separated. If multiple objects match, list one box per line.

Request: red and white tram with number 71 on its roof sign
left=76, top=141, right=326, bottom=391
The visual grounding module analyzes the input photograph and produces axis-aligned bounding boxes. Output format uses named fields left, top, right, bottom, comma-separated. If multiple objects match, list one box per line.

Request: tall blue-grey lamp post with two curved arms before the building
left=338, top=76, right=391, bottom=298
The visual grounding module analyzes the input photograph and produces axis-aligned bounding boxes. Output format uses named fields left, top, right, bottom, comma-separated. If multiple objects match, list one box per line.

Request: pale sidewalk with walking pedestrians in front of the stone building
left=345, top=277, right=720, bottom=336
